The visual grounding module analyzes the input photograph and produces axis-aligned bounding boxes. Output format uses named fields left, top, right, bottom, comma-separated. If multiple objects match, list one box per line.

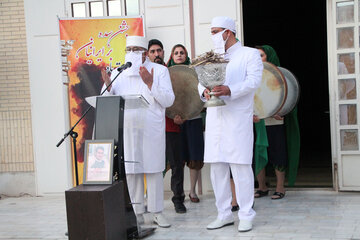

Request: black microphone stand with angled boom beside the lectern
left=56, top=67, right=126, bottom=186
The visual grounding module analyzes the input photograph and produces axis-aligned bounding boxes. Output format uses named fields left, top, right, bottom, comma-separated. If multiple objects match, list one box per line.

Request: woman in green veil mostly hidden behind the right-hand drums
left=254, top=45, right=300, bottom=200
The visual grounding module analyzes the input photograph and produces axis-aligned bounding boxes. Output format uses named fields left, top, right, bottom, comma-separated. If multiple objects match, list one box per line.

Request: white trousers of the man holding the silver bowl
left=210, top=163, right=256, bottom=221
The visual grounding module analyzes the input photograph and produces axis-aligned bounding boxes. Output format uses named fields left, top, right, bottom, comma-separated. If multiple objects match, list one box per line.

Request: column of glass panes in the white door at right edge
left=334, top=0, right=360, bottom=154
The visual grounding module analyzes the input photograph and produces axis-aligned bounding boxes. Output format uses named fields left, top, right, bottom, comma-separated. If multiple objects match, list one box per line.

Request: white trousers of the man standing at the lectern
left=126, top=172, right=164, bottom=214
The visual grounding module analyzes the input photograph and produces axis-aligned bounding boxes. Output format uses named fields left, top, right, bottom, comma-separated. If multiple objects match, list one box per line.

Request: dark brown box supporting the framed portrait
left=65, top=181, right=137, bottom=240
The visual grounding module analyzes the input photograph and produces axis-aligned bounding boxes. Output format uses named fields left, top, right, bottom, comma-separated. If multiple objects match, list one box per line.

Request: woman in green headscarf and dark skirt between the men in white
left=167, top=44, right=204, bottom=203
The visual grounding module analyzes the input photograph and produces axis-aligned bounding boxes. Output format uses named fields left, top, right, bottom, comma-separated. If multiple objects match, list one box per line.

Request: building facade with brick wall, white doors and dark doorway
left=0, top=0, right=360, bottom=195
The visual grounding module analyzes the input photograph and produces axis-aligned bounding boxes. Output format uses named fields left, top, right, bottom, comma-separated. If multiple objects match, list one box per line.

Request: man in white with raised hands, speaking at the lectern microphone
left=103, top=36, right=175, bottom=227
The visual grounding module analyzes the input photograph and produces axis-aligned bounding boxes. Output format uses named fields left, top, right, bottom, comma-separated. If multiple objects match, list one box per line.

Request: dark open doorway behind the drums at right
left=243, top=0, right=333, bottom=187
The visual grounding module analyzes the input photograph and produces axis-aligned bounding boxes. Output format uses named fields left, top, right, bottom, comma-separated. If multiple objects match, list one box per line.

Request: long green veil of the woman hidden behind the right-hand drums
left=254, top=45, right=300, bottom=186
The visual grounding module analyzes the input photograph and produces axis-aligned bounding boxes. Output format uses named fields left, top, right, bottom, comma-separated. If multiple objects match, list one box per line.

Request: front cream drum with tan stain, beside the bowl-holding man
left=254, top=62, right=287, bottom=119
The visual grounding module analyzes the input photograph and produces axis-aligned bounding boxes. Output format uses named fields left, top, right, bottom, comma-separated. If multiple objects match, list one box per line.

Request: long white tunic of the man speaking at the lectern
left=104, top=59, right=175, bottom=174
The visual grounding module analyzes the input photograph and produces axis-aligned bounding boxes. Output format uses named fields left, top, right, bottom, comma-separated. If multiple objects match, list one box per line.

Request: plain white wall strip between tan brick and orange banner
left=24, top=0, right=72, bottom=195
